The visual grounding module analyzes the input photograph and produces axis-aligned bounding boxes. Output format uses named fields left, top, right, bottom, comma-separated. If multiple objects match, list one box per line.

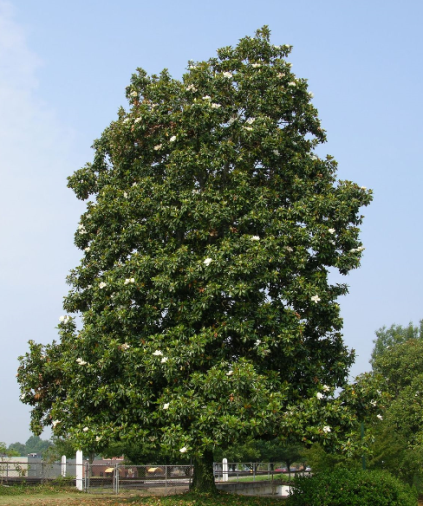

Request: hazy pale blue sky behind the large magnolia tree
left=0, top=0, right=423, bottom=444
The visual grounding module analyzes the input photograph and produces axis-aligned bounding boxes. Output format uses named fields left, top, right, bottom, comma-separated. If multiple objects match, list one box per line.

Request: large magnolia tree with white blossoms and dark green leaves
left=18, top=27, right=371, bottom=490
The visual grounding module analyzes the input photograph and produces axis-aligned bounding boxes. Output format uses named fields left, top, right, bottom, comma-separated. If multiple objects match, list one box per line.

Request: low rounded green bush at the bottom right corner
left=288, top=469, right=417, bottom=506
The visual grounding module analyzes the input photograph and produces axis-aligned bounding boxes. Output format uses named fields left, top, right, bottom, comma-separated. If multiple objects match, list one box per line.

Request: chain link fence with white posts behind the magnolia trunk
left=0, top=459, right=307, bottom=495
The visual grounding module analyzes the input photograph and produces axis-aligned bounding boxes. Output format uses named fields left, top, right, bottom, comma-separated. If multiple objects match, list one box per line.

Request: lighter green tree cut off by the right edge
left=364, top=322, right=423, bottom=484
